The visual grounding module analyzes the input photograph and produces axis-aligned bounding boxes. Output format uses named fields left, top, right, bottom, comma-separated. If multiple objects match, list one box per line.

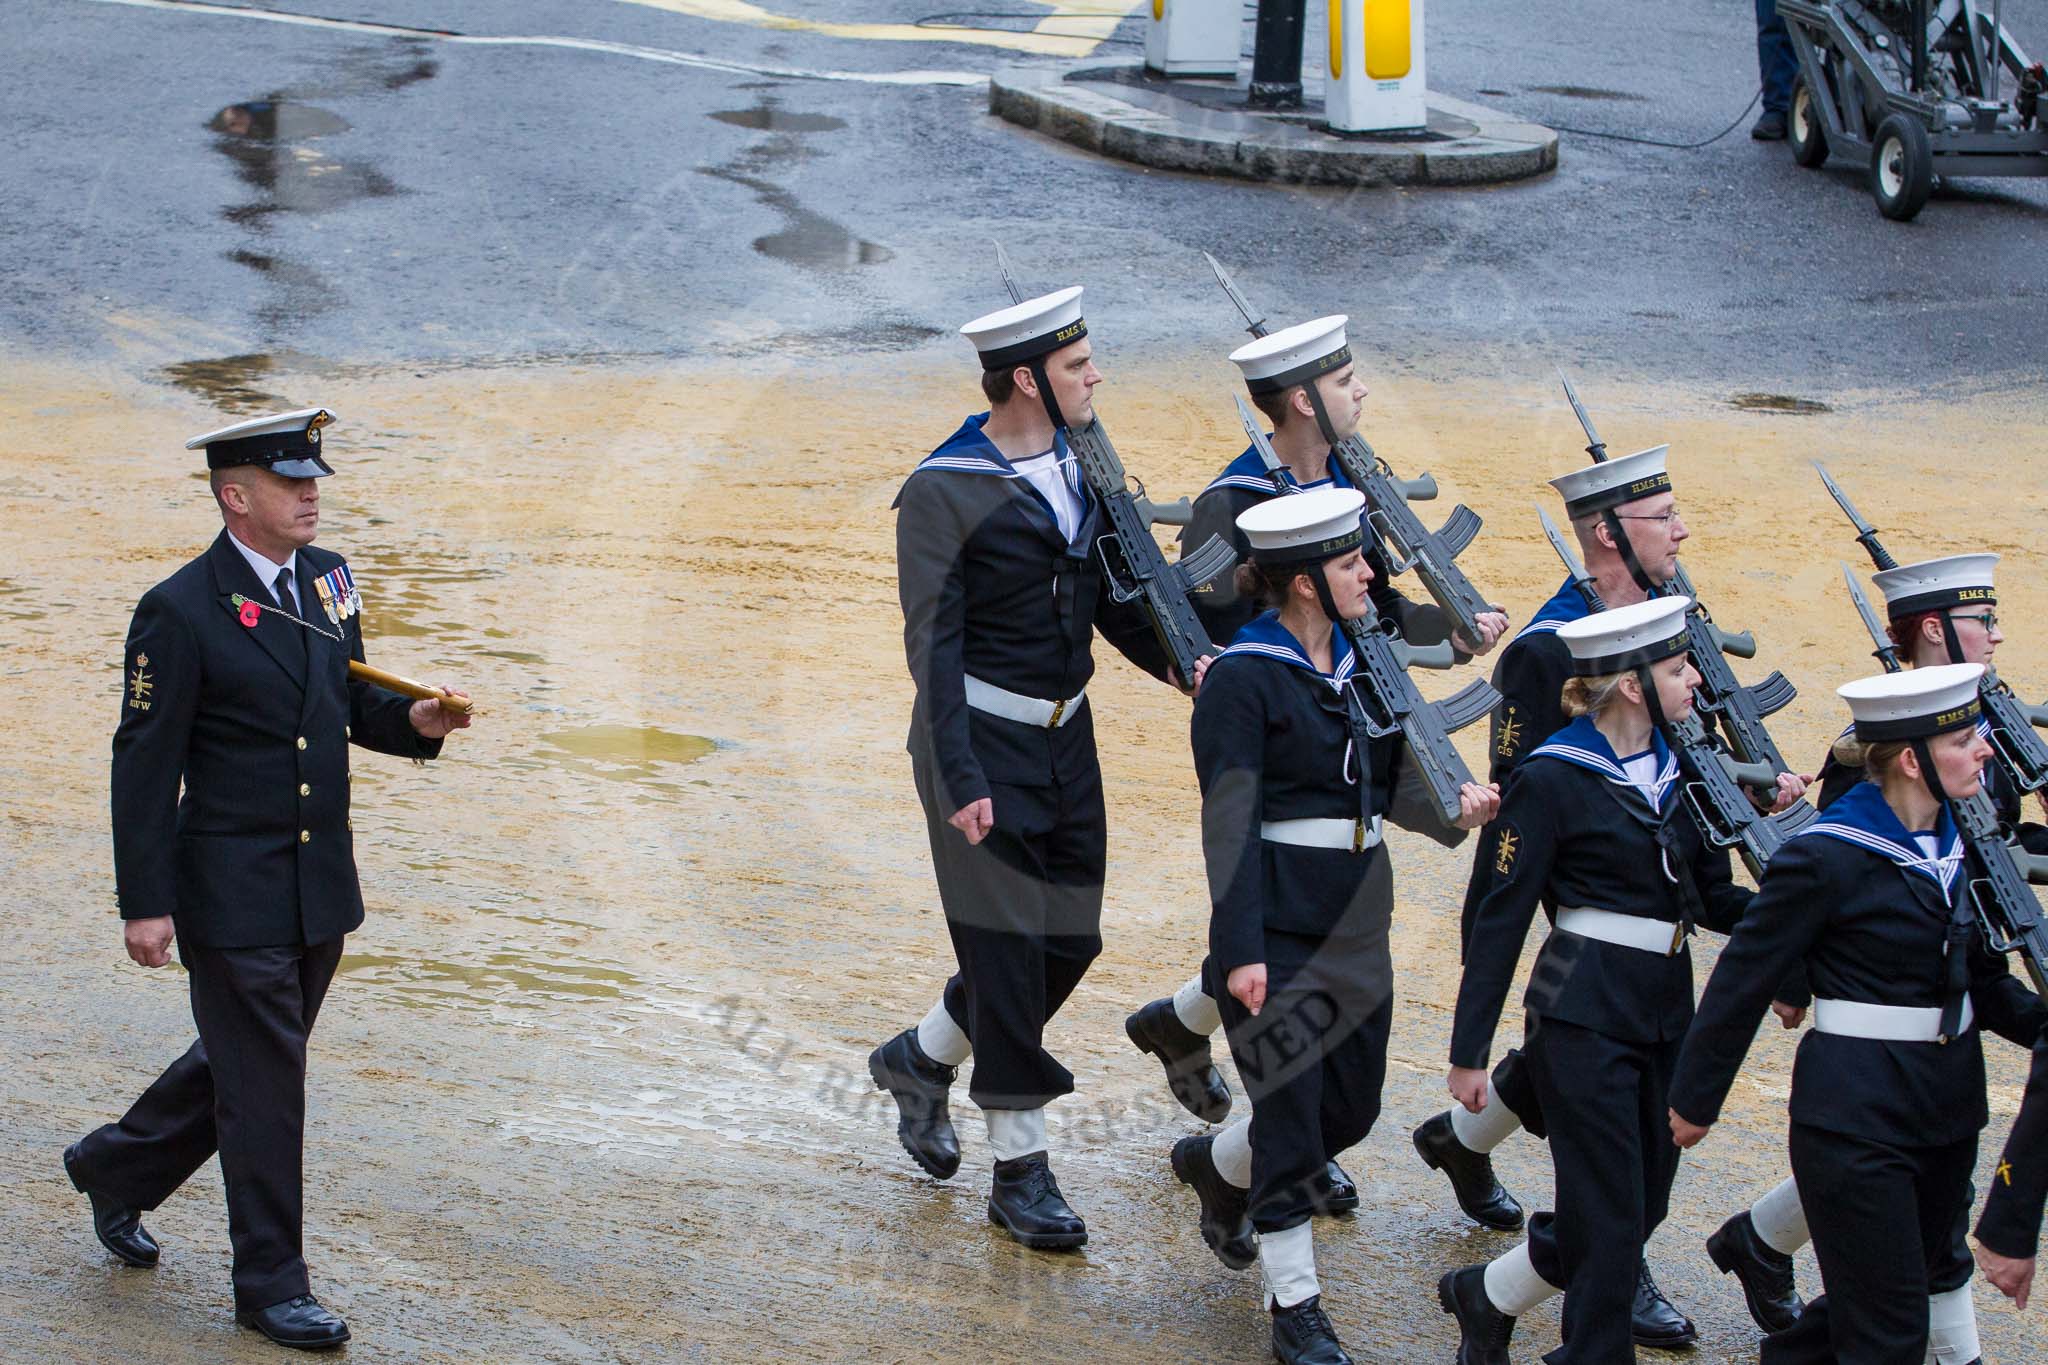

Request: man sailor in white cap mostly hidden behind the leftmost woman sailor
left=1124, top=313, right=1507, bottom=1212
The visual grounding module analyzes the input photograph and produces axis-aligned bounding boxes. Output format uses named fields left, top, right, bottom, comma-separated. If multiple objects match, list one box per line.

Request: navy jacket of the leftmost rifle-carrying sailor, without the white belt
left=895, top=413, right=1167, bottom=810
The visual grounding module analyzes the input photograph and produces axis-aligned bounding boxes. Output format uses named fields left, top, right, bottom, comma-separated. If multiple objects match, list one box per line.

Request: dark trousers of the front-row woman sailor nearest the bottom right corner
left=1761, top=1124, right=1976, bottom=1365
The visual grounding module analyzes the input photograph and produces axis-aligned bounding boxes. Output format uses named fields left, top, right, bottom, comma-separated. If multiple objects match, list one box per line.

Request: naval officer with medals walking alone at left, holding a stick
left=63, top=407, right=469, bottom=1349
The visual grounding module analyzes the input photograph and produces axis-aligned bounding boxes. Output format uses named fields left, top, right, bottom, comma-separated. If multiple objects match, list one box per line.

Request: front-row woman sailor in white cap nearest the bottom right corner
left=1671, top=663, right=2040, bottom=1365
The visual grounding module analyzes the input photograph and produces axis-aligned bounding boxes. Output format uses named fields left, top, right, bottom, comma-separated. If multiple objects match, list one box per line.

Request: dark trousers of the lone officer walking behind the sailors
left=76, top=939, right=342, bottom=1312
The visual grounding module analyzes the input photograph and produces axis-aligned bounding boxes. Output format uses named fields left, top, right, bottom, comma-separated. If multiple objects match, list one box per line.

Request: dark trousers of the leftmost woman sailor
left=1208, top=916, right=1395, bottom=1232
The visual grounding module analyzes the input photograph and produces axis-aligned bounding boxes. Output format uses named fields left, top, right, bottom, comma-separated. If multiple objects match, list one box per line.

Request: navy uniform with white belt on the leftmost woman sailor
left=1190, top=612, right=1464, bottom=1232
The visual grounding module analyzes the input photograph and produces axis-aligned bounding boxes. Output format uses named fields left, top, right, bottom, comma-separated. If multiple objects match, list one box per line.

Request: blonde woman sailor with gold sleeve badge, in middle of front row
left=1438, top=596, right=1749, bottom=1365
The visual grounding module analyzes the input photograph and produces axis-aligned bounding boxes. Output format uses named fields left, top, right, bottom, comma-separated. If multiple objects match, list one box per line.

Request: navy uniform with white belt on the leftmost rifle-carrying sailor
left=895, top=413, right=1167, bottom=1109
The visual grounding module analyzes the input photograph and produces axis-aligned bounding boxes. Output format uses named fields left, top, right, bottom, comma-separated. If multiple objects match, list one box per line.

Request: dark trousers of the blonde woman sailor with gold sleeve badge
left=1528, top=1019, right=1683, bottom=1365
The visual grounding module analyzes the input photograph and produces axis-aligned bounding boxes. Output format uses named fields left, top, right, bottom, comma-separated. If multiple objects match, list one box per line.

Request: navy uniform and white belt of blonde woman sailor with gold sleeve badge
left=1450, top=720, right=1749, bottom=1365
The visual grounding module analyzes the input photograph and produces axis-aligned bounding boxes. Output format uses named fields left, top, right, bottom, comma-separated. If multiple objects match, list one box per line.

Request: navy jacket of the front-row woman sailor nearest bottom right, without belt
left=1671, top=782, right=2042, bottom=1146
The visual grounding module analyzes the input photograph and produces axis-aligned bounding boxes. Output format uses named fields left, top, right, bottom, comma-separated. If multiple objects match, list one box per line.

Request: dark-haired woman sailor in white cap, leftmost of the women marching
left=1174, top=489, right=1499, bottom=1363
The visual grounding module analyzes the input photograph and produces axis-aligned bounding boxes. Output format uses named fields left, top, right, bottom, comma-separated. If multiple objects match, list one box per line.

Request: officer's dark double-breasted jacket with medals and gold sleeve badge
left=113, top=530, right=440, bottom=948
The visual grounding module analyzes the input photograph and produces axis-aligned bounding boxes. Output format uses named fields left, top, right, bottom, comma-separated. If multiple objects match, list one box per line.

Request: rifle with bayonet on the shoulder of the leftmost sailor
left=995, top=244, right=1237, bottom=688
